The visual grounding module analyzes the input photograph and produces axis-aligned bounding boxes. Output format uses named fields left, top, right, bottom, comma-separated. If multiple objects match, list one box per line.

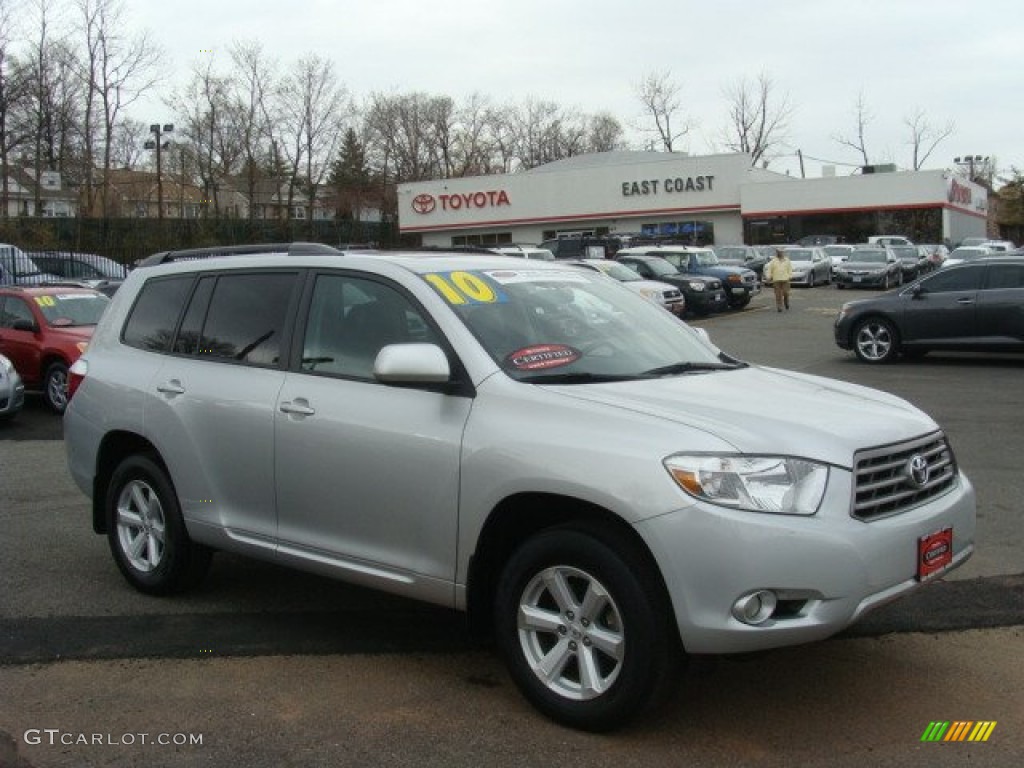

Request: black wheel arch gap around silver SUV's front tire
left=466, top=494, right=678, bottom=641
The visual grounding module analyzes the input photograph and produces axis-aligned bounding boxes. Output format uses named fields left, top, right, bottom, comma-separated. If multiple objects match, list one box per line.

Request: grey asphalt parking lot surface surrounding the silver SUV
left=0, top=288, right=1024, bottom=768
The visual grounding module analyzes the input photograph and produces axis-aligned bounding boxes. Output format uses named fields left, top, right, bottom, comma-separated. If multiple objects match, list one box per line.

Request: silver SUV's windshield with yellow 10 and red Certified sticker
left=423, top=269, right=733, bottom=384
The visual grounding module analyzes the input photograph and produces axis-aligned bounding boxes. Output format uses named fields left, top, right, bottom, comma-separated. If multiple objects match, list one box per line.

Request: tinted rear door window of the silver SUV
left=198, top=272, right=297, bottom=366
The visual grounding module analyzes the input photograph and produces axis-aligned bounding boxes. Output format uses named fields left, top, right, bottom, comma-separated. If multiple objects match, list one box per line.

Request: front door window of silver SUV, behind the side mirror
left=301, top=274, right=438, bottom=379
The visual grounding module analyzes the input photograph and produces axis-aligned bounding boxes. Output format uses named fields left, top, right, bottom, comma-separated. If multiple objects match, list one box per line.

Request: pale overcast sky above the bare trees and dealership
left=132, top=0, right=1024, bottom=183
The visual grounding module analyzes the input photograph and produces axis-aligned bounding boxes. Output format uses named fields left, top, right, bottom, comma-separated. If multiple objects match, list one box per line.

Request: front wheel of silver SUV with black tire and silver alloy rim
left=495, top=527, right=682, bottom=732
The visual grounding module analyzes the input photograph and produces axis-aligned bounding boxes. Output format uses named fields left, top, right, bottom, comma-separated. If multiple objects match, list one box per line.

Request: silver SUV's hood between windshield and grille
left=548, top=366, right=938, bottom=468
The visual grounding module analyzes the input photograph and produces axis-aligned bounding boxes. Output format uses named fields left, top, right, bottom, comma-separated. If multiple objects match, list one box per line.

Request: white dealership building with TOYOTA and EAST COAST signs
left=398, top=152, right=988, bottom=247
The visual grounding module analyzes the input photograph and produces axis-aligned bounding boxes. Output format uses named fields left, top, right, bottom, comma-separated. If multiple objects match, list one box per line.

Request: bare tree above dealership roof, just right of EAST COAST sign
left=725, top=72, right=793, bottom=165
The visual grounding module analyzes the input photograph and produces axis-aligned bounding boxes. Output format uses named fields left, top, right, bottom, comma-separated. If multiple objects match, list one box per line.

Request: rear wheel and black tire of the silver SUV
left=105, top=455, right=212, bottom=595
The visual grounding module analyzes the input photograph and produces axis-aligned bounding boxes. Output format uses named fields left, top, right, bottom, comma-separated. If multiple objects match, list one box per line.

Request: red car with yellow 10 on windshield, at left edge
left=0, top=286, right=111, bottom=414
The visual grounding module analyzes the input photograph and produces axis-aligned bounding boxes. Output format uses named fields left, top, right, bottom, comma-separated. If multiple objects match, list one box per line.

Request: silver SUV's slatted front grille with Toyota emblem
left=851, top=433, right=956, bottom=521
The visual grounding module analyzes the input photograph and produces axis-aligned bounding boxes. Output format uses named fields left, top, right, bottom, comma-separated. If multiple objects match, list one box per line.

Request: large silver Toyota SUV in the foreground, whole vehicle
left=65, top=249, right=975, bottom=730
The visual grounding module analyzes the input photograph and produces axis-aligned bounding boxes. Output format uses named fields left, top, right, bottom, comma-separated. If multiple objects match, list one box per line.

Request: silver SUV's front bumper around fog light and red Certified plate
left=637, top=468, right=976, bottom=653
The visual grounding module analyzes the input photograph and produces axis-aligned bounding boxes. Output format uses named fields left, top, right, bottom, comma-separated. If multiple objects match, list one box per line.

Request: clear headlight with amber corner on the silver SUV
left=665, top=454, right=828, bottom=515
